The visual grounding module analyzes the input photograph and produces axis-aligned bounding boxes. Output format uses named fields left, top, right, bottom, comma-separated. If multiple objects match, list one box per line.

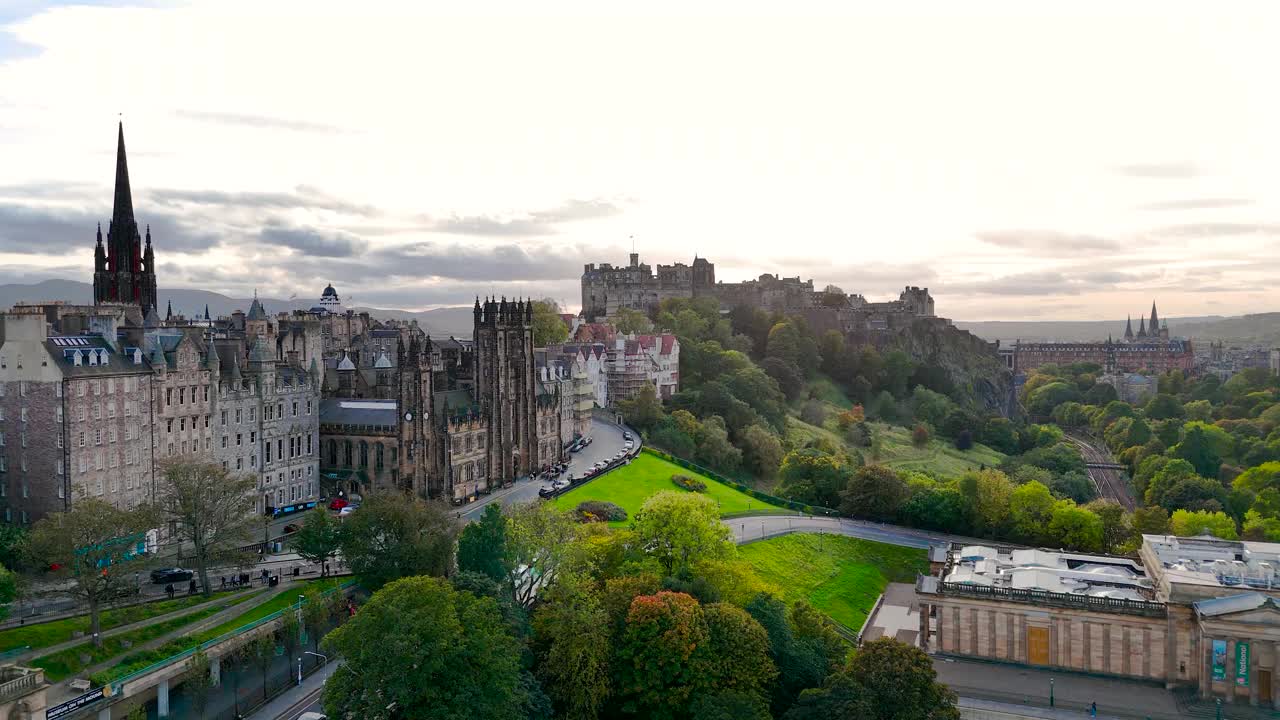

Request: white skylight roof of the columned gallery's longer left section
left=942, top=544, right=1152, bottom=601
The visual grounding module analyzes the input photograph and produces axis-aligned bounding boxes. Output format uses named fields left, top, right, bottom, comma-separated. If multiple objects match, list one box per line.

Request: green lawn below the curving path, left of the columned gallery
left=739, top=533, right=929, bottom=633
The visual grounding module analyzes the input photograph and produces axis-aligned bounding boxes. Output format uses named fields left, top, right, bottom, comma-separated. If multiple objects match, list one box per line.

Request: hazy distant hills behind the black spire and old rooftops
left=0, top=281, right=471, bottom=337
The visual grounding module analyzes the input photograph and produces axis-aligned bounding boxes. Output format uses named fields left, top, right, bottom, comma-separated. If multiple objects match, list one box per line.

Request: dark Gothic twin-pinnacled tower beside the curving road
left=472, top=297, right=539, bottom=483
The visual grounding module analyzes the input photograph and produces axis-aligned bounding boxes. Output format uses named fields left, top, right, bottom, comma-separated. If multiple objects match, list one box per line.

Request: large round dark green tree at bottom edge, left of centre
left=323, top=571, right=525, bottom=720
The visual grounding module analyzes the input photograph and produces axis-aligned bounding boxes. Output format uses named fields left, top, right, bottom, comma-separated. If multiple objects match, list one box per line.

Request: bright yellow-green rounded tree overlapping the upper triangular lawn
left=635, top=491, right=733, bottom=575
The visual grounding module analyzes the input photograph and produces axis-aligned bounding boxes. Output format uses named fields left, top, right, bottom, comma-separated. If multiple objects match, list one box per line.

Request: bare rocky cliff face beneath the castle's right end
left=849, top=316, right=1016, bottom=418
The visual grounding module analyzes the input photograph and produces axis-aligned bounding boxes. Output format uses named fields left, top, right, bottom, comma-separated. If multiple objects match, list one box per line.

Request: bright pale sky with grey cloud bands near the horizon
left=0, top=0, right=1280, bottom=320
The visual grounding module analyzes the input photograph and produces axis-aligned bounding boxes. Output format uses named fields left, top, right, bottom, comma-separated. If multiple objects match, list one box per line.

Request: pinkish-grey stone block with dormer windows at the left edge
left=0, top=311, right=155, bottom=524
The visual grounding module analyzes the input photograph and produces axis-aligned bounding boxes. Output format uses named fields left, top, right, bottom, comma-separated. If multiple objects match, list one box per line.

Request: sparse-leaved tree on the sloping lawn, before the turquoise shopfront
left=31, top=498, right=155, bottom=647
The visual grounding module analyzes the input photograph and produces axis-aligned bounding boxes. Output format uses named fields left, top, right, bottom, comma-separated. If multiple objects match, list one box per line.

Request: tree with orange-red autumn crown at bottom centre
left=617, top=591, right=710, bottom=720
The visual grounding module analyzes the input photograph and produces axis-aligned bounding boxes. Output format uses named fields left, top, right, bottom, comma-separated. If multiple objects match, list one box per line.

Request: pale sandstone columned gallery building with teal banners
left=916, top=536, right=1280, bottom=708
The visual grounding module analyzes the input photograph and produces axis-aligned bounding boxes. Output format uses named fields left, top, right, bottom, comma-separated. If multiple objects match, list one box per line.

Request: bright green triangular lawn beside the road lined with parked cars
left=553, top=452, right=781, bottom=525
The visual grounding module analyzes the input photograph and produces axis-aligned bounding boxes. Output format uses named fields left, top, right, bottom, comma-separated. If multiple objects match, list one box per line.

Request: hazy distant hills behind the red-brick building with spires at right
left=956, top=313, right=1280, bottom=346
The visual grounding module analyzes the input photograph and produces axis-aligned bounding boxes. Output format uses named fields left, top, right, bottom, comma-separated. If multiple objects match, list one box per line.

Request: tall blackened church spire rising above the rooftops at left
left=93, top=123, right=156, bottom=315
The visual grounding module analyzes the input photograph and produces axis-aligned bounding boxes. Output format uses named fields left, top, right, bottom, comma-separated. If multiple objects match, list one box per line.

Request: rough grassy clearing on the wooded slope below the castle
left=787, top=418, right=1005, bottom=478
